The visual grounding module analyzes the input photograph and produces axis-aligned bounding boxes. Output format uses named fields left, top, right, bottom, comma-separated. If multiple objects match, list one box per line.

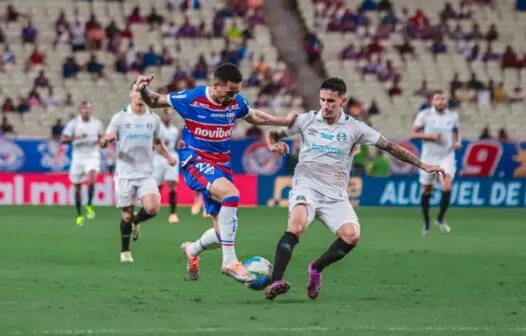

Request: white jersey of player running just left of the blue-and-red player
left=106, top=105, right=161, bottom=179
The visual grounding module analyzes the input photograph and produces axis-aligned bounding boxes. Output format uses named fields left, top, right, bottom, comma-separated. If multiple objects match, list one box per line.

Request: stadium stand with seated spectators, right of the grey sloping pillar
left=297, top=0, right=526, bottom=139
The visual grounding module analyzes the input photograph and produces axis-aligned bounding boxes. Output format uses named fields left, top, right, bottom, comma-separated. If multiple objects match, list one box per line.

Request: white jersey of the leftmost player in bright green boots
left=62, top=116, right=104, bottom=160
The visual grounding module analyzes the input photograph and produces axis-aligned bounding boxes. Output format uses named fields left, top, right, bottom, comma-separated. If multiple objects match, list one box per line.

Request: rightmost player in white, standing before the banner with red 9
left=412, top=91, right=462, bottom=236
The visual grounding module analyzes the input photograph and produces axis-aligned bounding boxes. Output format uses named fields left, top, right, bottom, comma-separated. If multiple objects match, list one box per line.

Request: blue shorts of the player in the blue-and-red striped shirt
left=183, top=162, right=234, bottom=215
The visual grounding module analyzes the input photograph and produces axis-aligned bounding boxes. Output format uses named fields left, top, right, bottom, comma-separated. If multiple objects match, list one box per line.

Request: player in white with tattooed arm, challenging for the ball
left=265, top=78, right=445, bottom=300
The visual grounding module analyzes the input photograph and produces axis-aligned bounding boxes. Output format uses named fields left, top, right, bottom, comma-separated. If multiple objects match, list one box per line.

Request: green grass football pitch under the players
left=0, top=207, right=526, bottom=336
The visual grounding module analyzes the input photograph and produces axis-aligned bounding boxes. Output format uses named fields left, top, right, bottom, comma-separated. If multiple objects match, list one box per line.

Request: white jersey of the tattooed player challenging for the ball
left=284, top=111, right=380, bottom=200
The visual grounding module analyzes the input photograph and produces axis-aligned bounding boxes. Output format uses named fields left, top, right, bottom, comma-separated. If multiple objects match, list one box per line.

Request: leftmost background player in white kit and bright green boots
left=61, top=102, right=103, bottom=226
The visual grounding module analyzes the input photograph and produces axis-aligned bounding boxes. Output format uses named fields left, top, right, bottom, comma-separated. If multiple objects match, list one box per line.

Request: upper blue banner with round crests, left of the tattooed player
left=0, top=137, right=292, bottom=176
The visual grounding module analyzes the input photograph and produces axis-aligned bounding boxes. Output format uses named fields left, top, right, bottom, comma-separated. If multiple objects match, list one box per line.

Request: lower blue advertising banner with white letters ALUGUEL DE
left=258, top=176, right=526, bottom=207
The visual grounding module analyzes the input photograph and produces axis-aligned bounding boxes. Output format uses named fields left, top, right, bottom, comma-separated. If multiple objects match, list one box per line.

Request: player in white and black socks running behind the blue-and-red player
left=100, top=82, right=177, bottom=262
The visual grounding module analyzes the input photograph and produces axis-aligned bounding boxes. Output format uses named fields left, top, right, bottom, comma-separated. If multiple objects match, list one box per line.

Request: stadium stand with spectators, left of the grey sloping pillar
left=0, top=0, right=303, bottom=136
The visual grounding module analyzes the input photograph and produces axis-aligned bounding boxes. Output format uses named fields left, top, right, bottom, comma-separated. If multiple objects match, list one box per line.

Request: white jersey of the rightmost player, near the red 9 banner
left=413, top=107, right=459, bottom=162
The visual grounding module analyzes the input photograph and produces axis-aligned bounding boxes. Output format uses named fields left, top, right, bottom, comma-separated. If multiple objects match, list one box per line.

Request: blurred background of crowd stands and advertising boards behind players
left=0, top=0, right=526, bottom=206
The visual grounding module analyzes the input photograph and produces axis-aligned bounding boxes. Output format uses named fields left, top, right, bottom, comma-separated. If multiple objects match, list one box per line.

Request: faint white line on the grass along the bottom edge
left=9, top=326, right=526, bottom=336
